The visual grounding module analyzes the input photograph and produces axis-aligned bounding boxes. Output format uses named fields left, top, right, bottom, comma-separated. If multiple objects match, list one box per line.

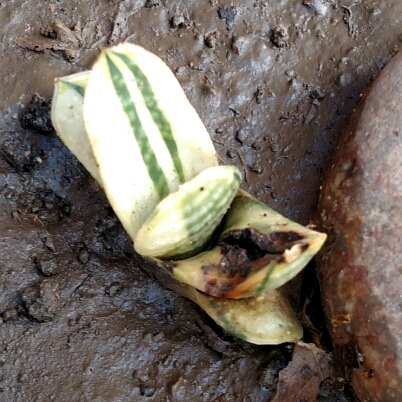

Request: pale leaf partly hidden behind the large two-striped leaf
left=51, top=71, right=101, bottom=184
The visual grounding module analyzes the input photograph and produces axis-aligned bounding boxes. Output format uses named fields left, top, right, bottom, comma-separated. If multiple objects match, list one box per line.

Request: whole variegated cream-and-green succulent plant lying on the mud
left=52, top=44, right=326, bottom=344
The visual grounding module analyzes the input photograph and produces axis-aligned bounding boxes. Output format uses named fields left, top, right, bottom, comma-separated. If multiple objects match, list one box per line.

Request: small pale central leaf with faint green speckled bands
left=134, top=166, right=241, bottom=260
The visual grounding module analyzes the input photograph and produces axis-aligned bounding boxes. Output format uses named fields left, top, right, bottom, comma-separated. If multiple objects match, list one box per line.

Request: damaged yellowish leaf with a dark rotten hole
left=164, top=191, right=327, bottom=299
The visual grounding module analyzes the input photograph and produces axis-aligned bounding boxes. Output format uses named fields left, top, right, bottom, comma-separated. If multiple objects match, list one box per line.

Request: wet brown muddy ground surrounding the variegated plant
left=0, top=0, right=402, bottom=402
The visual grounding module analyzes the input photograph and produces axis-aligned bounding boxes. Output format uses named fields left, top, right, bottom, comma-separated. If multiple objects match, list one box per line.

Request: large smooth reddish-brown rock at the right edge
left=319, top=53, right=402, bottom=402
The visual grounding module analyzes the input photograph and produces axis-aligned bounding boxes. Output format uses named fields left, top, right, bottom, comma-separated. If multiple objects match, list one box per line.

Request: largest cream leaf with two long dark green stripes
left=84, top=44, right=217, bottom=239
